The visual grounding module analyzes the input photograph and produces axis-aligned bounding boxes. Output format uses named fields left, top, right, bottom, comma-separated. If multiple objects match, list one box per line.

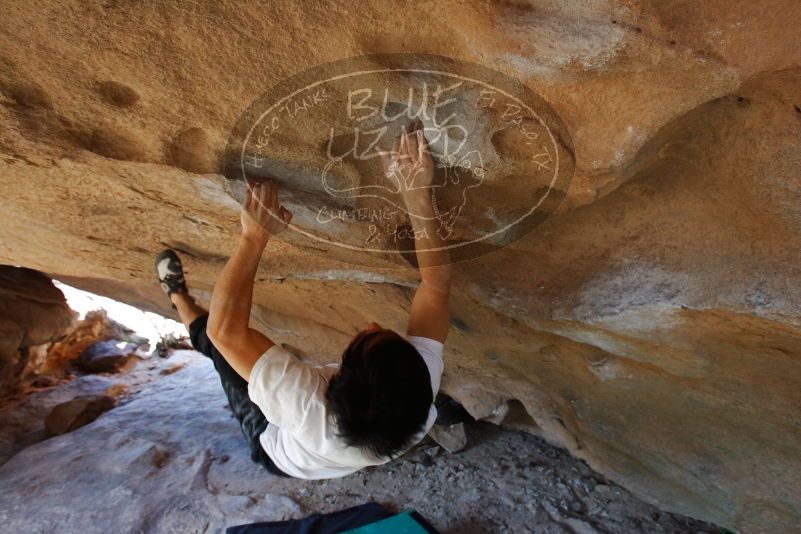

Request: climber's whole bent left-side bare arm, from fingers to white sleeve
left=206, top=182, right=292, bottom=380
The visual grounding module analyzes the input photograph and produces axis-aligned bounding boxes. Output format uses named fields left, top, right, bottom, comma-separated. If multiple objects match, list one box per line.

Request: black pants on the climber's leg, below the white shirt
left=189, top=314, right=289, bottom=477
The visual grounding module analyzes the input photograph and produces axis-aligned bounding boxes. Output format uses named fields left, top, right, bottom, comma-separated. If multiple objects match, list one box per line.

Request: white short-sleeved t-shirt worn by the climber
left=248, top=336, right=444, bottom=479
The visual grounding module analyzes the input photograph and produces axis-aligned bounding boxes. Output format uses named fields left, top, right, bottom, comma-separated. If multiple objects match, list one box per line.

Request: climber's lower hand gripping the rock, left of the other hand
left=241, top=180, right=292, bottom=244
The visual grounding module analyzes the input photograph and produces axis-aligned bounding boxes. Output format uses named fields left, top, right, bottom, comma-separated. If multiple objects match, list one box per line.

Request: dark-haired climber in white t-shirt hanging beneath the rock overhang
left=156, top=122, right=452, bottom=479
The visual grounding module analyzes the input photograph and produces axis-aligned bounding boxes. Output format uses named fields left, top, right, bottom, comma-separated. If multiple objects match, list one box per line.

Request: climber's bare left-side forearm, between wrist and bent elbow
left=207, top=235, right=267, bottom=341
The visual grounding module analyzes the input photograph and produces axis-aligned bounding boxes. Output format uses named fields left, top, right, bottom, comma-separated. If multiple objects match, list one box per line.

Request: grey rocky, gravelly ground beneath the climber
left=0, top=351, right=721, bottom=534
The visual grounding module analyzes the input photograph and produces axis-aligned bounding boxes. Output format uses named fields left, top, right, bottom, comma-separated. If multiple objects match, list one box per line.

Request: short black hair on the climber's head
left=325, top=330, right=434, bottom=458
